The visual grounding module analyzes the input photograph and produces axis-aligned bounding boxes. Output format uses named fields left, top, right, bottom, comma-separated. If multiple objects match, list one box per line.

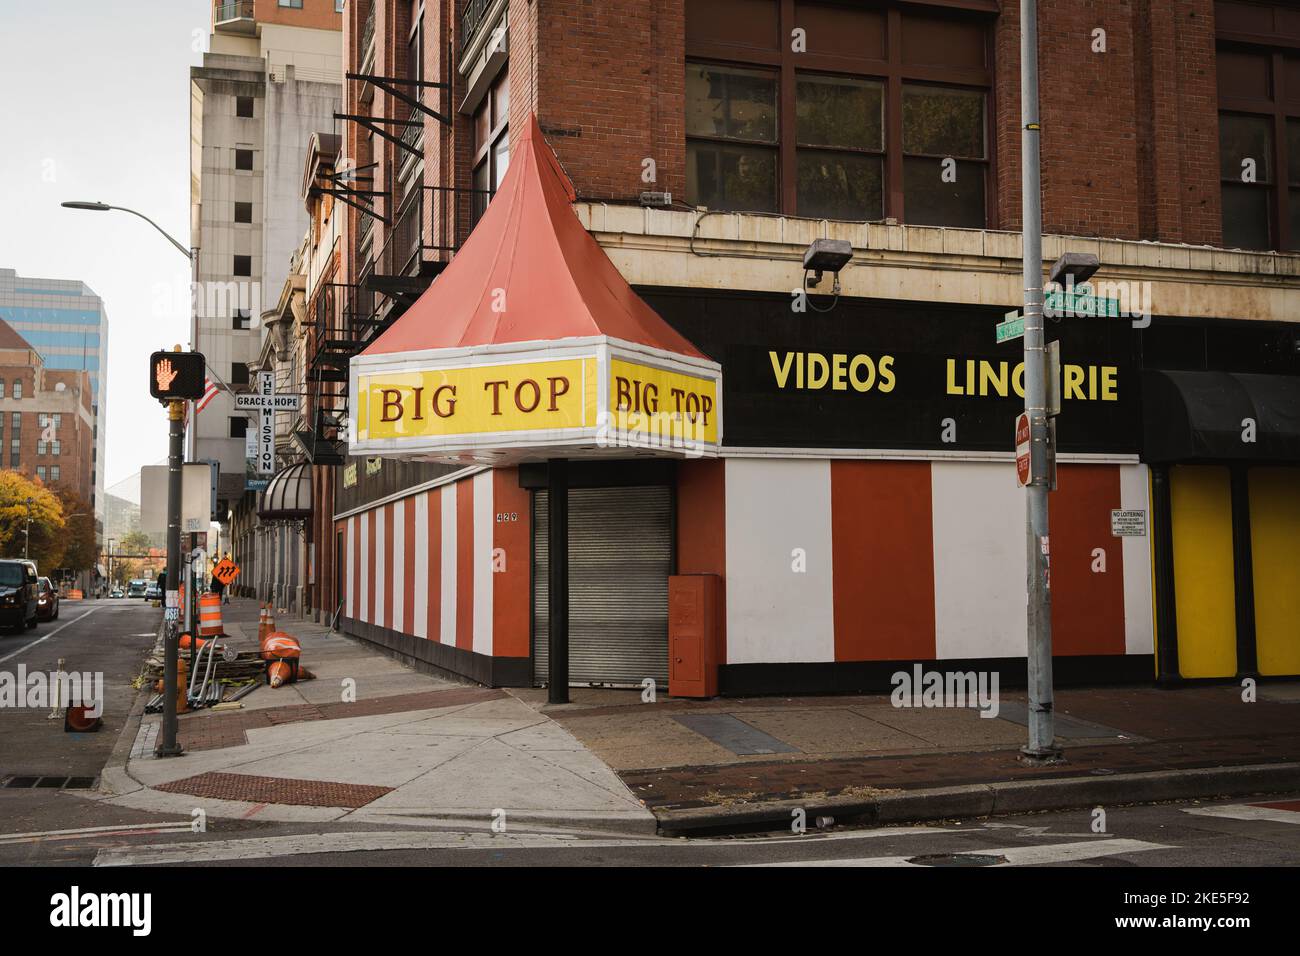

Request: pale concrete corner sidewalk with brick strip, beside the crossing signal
left=101, top=600, right=655, bottom=835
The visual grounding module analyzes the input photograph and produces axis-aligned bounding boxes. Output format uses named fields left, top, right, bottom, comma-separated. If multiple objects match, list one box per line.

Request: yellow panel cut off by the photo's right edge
left=1249, top=468, right=1300, bottom=675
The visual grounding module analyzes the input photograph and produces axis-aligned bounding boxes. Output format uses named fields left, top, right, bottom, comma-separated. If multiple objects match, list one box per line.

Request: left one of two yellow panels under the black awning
left=1170, top=464, right=1236, bottom=678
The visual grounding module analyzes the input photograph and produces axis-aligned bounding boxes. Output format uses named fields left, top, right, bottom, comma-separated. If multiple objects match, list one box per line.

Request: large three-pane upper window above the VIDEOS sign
left=685, top=0, right=992, bottom=228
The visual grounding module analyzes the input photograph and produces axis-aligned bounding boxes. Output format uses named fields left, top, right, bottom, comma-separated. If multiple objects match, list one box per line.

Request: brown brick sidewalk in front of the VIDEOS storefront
left=515, top=683, right=1300, bottom=832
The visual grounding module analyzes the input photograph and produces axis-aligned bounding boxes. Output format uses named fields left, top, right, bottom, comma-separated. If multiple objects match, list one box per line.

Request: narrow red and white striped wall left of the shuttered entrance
left=339, top=468, right=530, bottom=658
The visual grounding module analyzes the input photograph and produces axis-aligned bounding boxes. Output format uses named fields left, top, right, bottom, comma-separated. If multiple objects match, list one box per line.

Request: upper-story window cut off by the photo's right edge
left=1217, top=46, right=1300, bottom=251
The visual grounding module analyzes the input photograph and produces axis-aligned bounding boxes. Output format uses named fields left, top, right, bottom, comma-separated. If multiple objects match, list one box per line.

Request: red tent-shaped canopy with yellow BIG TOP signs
left=348, top=117, right=722, bottom=464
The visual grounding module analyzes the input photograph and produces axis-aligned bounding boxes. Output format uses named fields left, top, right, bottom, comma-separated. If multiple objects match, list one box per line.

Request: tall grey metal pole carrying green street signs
left=1021, top=0, right=1061, bottom=762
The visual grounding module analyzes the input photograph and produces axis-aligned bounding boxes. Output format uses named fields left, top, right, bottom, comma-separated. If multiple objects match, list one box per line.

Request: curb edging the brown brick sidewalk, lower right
left=653, top=762, right=1300, bottom=836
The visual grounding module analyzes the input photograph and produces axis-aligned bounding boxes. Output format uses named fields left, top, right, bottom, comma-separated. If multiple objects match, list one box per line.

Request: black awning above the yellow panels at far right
left=1141, top=369, right=1300, bottom=462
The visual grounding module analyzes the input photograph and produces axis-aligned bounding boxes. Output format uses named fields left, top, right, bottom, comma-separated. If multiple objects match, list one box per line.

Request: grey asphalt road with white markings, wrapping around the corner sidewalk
left=0, top=600, right=1300, bottom=868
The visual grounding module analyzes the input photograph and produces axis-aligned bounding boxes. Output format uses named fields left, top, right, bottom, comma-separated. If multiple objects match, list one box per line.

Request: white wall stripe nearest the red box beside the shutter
left=727, top=458, right=835, bottom=663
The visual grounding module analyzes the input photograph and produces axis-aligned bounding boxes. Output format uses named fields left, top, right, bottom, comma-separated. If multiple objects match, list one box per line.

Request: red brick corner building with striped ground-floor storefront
left=301, top=0, right=1300, bottom=692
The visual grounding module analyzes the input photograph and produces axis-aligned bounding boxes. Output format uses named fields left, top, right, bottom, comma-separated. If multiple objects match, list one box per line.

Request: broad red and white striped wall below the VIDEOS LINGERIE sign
left=717, top=458, right=1153, bottom=665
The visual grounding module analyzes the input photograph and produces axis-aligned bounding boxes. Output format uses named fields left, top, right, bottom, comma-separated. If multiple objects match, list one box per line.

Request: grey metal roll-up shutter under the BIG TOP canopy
left=533, top=485, right=672, bottom=688
